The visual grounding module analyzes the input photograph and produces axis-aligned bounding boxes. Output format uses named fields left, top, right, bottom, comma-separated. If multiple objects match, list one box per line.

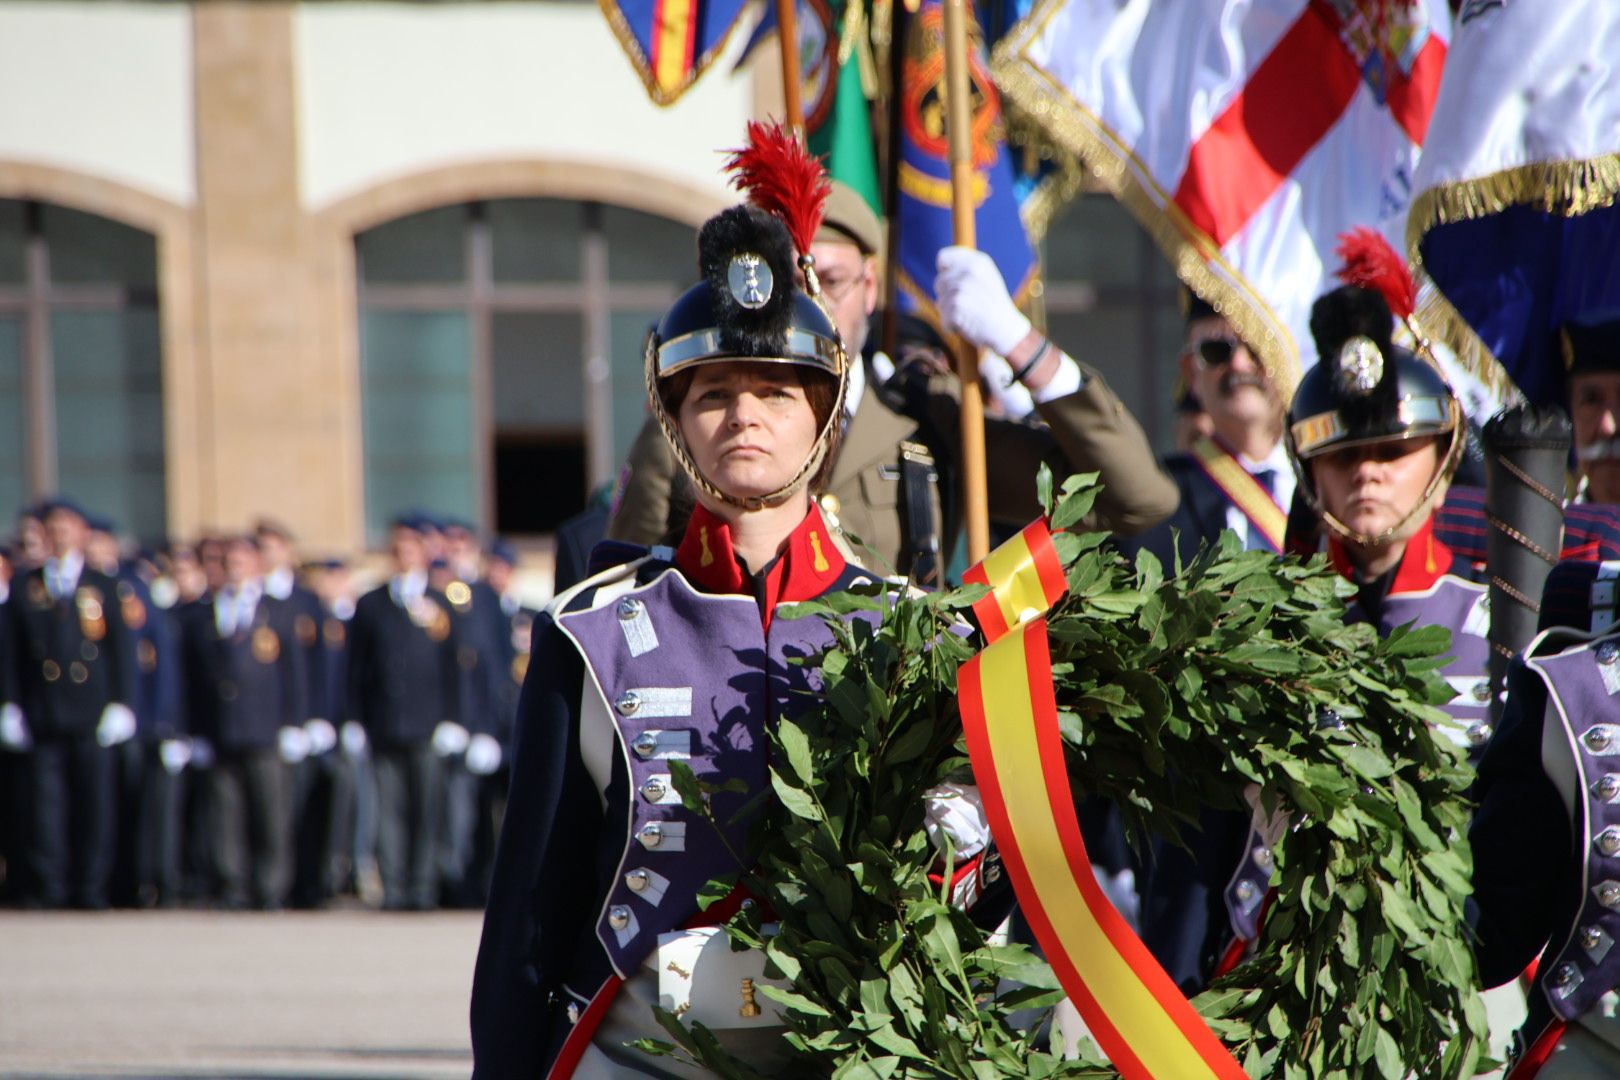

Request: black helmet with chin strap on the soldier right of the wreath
left=1288, top=285, right=1464, bottom=546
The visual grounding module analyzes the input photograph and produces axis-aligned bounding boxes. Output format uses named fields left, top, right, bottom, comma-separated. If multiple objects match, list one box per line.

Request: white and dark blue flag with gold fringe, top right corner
left=1406, top=0, right=1620, bottom=405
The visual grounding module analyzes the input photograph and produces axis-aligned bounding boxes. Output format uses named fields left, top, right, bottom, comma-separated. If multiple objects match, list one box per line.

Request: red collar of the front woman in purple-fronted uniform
left=676, top=502, right=846, bottom=625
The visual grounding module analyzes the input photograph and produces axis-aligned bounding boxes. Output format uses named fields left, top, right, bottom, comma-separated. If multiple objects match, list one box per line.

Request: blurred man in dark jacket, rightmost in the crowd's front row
left=348, top=517, right=471, bottom=910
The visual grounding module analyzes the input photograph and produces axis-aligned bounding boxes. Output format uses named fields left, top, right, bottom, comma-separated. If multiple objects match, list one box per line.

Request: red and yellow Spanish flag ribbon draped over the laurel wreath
left=957, top=521, right=1244, bottom=1080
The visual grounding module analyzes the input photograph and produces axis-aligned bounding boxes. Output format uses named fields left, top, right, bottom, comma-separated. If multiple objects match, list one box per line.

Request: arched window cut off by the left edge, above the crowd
left=0, top=199, right=167, bottom=539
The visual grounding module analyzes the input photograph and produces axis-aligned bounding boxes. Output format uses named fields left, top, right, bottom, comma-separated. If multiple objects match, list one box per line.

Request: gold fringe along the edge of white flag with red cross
left=991, top=0, right=1301, bottom=402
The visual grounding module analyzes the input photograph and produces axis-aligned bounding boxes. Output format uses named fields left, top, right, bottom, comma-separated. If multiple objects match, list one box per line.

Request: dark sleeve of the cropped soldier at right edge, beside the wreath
left=1468, top=661, right=1580, bottom=986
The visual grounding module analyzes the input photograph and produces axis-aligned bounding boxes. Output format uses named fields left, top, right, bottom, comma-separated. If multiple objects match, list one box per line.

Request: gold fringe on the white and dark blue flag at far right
left=1406, top=154, right=1620, bottom=403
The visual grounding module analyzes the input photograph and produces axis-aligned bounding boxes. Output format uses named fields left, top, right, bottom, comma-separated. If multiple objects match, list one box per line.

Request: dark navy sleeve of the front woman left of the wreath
left=471, top=620, right=603, bottom=1080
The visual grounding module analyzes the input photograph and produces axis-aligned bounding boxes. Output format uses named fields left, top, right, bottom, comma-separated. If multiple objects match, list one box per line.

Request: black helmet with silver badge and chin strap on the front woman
left=646, top=204, right=849, bottom=510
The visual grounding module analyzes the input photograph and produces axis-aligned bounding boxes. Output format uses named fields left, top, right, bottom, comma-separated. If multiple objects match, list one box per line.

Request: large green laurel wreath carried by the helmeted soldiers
left=640, top=474, right=1486, bottom=1080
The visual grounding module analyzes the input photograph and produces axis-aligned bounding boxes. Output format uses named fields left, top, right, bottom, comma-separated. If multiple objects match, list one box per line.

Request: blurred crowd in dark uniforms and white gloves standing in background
left=0, top=499, right=536, bottom=910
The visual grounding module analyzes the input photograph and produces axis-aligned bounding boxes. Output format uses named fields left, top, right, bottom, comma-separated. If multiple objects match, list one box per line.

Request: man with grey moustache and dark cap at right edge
left=1560, top=308, right=1620, bottom=504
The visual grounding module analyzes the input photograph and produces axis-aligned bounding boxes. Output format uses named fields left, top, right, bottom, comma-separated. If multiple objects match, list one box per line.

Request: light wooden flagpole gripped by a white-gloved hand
left=943, top=0, right=990, bottom=563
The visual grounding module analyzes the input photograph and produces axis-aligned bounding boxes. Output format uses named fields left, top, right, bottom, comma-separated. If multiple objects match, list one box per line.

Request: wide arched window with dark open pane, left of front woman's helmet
left=355, top=199, right=697, bottom=541
